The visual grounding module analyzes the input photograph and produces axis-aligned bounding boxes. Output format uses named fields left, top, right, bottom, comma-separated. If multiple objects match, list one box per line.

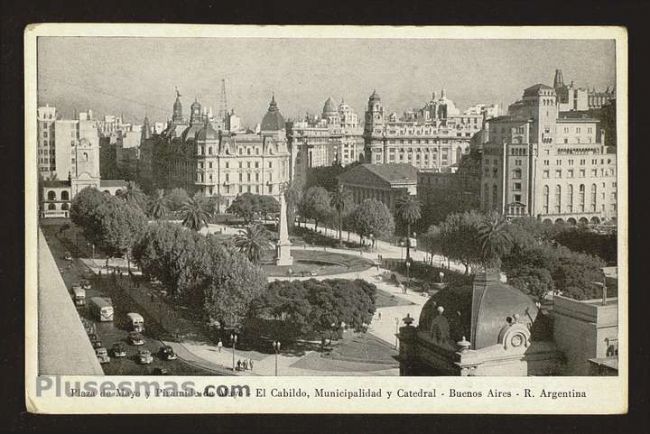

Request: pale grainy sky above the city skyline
left=38, top=37, right=616, bottom=127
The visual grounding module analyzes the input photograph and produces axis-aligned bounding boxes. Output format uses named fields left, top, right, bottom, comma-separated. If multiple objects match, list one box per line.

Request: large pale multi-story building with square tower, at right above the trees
left=481, top=84, right=617, bottom=224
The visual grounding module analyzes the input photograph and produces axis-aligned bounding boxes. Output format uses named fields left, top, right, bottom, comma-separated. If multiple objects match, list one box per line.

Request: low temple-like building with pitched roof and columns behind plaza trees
left=338, top=163, right=418, bottom=211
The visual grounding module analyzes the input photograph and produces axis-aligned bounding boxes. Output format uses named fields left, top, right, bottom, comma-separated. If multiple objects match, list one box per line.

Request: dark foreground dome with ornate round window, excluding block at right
left=400, top=271, right=563, bottom=376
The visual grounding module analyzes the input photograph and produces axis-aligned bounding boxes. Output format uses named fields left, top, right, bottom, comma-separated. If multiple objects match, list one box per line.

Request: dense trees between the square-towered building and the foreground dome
left=422, top=211, right=605, bottom=300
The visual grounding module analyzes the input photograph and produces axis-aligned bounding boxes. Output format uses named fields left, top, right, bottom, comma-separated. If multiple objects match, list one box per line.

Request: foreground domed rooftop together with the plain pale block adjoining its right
left=398, top=270, right=618, bottom=376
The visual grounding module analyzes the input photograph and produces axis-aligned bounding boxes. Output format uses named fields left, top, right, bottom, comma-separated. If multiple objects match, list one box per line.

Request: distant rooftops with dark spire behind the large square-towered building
left=553, top=69, right=616, bottom=111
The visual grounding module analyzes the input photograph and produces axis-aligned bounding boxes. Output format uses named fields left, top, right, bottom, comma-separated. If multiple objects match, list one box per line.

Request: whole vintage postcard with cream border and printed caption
left=25, top=24, right=629, bottom=414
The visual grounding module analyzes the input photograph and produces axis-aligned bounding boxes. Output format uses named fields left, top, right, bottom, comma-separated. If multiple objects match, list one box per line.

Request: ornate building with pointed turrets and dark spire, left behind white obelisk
left=144, top=95, right=293, bottom=211
